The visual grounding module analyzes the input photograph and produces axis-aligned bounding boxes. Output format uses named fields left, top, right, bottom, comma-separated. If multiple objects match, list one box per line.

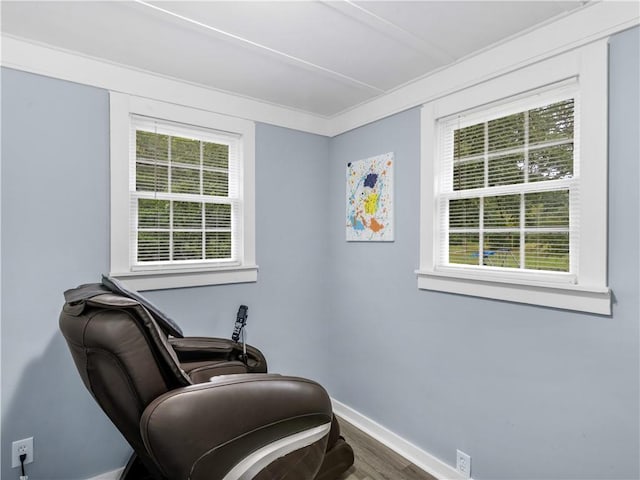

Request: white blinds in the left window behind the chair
left=129, top=115, right=242, bottom=269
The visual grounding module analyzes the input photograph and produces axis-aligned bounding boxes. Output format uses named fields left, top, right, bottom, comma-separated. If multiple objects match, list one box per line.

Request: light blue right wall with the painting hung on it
left=329, top=28, right=640, bottom=480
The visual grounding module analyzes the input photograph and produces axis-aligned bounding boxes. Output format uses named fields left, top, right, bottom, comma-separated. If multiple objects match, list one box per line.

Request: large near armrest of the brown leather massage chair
left=140, top=374, right=332, bottom=480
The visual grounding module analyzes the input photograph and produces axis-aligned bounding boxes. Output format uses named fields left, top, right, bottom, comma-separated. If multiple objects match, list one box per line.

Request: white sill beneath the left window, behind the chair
left=110, top=265, right=258, bottom=291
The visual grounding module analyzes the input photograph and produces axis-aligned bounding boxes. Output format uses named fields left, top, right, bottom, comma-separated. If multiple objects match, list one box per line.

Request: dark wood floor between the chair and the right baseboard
left=340, top=418, right=437, bottom=480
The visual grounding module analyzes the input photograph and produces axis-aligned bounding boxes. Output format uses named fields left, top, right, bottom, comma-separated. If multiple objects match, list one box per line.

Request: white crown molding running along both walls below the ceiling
left=0, top=1, right=640, bottom=137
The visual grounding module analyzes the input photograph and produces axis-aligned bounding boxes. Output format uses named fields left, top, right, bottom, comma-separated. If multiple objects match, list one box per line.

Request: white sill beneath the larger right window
left=416, top=270, right=611, bottom=315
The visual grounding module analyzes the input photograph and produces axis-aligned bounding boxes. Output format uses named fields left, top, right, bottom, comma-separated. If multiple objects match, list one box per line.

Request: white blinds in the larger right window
left=437, top=87, right=580, bottom=282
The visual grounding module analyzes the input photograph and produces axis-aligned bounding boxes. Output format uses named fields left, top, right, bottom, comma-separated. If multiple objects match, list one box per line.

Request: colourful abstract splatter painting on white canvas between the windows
left=347, top=152, right=393, bottom=242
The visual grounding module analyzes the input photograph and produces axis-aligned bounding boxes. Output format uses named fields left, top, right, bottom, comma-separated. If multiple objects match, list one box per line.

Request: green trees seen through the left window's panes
left=133, top=129, right=233, bottom=263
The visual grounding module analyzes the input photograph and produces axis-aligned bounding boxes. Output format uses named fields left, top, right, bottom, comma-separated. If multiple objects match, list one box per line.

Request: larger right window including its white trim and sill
left=418, top=41, right=610, bottom=314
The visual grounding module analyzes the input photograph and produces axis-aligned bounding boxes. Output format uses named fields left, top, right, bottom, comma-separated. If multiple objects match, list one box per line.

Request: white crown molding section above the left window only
left=0, top=34, right=329, bottom=135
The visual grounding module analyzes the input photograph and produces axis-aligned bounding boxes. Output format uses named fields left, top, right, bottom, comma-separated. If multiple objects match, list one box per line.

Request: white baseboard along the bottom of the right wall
left=331, top=398, right=464, bottom=480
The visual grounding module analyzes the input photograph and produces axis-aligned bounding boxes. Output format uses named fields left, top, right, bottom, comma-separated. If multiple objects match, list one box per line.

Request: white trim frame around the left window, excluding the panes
left=110, top=92, right=258, bottom=290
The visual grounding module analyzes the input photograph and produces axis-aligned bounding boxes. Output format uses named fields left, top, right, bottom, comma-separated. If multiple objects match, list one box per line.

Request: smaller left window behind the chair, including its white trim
left=111, top=93, right=256, bottom=290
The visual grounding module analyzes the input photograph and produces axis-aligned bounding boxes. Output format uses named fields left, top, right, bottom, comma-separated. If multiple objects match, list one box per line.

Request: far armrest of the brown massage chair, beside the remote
left=169, top=337, right=267, bottom=373
